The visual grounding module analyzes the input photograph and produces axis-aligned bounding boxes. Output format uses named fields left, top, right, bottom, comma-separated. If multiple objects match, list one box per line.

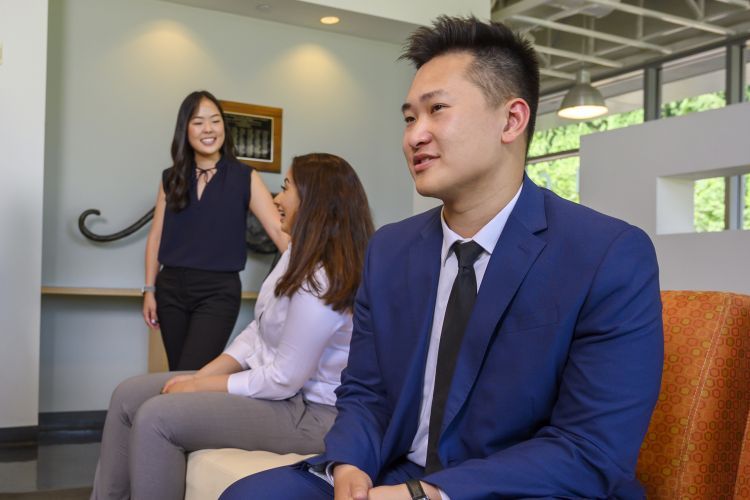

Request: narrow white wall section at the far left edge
left=0, top=0, right=47, bottom=427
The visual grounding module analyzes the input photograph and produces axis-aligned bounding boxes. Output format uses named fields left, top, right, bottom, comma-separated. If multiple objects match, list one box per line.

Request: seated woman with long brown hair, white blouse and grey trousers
left=92, top=153, right=373, bottom=499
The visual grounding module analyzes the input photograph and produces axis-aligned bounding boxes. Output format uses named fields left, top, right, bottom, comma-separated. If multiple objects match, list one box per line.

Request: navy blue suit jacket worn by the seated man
left=311, top=178, right=663, bottom=500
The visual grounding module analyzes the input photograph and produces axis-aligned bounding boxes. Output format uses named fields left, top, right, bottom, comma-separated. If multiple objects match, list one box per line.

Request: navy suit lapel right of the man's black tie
left=441, top=178, right=547, bottom=433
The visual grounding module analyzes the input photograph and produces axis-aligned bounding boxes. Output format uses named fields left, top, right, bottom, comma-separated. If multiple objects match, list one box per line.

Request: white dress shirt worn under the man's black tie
left=406, top=188, right=521, bottom=468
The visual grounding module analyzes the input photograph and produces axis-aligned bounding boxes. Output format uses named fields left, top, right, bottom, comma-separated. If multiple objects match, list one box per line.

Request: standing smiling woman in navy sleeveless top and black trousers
left=143, top=90, right=289, bottom=371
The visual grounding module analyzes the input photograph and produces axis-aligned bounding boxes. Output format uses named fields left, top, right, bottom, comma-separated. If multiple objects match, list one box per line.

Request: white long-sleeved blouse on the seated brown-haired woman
left=224, top=246, right=352, bottom=405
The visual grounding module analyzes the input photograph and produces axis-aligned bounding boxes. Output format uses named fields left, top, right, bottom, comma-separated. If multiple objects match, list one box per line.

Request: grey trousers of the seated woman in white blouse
left=91, top=372, right=336, bottom=500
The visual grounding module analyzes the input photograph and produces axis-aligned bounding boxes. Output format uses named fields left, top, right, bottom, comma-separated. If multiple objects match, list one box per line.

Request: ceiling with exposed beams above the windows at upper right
left=492, top=0, right=750, bottom=93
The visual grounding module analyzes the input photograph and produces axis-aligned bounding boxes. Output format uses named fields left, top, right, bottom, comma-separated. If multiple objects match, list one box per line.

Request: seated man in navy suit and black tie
left=222, top=17, right=663, bottom=500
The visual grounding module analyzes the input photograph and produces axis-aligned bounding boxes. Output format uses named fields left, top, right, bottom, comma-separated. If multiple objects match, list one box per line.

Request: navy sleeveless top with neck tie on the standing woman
left=159, top=157, right=252, bottom=272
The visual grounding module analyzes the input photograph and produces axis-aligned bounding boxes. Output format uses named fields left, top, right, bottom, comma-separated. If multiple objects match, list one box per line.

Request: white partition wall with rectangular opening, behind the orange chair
left=580, top=103, right=750, bottom=294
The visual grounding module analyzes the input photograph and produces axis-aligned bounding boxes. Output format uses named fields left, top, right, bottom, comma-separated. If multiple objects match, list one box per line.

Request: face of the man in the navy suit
left=402, top=52, right=507, bottom=202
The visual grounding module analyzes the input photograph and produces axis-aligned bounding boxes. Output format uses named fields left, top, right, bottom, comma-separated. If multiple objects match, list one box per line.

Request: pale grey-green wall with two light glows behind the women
left=40, top=0, right=412, bottom=411
